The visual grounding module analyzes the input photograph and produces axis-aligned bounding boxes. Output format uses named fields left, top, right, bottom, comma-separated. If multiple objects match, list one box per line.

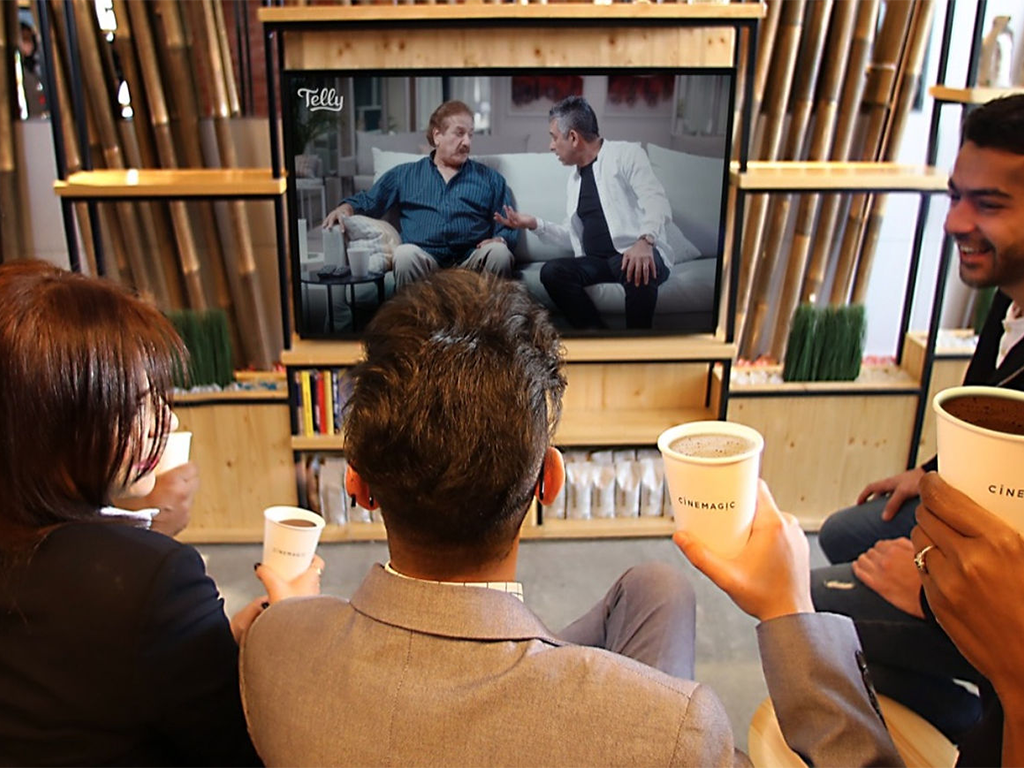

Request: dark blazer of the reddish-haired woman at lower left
left=0, top=522, right=259, bottom=768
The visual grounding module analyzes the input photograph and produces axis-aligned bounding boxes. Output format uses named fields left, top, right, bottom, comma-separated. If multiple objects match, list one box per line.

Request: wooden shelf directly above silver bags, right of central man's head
left=555, top=408, right=716, bottom=446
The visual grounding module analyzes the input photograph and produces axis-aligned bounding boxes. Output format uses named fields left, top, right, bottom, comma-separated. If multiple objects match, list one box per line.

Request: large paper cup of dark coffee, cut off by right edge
left=932, top=387, right=1024, bottom=534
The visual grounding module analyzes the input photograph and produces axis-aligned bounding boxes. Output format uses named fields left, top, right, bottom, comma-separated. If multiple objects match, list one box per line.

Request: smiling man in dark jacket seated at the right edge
left=811, top=95, right=1024, bottom=754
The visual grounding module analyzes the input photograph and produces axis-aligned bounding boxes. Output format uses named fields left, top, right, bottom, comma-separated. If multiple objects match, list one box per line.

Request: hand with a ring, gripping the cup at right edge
left=910, top=472, right=1024, bottom=714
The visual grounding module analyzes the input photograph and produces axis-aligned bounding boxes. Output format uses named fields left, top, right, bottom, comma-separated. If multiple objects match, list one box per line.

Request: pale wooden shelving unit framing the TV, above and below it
left=268, top=2, right=766, bottom=541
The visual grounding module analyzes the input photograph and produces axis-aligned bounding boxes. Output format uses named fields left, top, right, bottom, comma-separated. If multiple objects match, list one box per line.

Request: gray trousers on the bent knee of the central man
left=558, top=562, right=696, bottom=680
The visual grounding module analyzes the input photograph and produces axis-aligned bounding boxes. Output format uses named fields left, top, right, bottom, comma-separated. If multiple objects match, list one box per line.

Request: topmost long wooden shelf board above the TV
left=256, top=2, right=767, bottom=26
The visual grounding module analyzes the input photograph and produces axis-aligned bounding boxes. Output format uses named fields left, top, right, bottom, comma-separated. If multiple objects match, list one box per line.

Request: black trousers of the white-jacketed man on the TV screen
left=541, top=248, right=669, bottom=329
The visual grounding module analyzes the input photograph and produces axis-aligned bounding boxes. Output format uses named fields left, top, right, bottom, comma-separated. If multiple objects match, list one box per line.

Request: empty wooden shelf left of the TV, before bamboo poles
left=53, top=168, right=286, bottom=200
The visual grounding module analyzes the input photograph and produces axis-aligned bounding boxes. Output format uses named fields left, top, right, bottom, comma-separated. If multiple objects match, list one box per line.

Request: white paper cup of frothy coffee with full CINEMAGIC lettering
left=657, top=421, right=765, bottom=557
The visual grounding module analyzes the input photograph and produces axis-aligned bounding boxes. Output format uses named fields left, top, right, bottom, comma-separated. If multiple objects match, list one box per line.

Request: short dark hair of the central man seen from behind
left=345, top=269, right=565, bottom=571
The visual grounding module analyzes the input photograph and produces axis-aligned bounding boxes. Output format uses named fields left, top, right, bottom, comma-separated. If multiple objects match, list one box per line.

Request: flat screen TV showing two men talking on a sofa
left=282, top=69, right=735, bottom=339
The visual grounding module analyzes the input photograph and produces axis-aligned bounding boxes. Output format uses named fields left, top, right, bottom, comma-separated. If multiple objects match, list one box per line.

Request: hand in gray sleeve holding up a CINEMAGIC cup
left=673, top=480, right=814, bottom=622
